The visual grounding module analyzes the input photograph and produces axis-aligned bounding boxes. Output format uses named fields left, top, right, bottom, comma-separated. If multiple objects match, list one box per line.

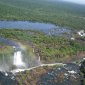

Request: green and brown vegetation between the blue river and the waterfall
left=0, top=29, right=85, bottom=62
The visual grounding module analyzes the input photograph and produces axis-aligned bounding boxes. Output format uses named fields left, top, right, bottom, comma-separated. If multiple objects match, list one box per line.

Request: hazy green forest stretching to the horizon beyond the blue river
left=0, top=0, right=85, bottom=29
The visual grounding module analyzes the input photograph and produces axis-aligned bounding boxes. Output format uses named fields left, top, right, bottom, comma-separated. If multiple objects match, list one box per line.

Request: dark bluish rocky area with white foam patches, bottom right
left=37, top=63, right=80, bottom=85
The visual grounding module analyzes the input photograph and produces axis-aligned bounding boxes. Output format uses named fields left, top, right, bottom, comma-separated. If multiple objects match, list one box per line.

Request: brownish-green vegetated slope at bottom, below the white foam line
left=16, top=67, right=52, bottom=85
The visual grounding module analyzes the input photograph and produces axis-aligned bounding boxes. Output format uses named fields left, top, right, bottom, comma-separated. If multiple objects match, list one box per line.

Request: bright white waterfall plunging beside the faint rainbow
left=13, top=51, right=26, bottom=67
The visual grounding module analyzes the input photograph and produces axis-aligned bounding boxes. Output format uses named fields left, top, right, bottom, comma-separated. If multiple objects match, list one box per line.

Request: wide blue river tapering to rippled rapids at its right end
left=0, top=21, right=70, bottom=35
